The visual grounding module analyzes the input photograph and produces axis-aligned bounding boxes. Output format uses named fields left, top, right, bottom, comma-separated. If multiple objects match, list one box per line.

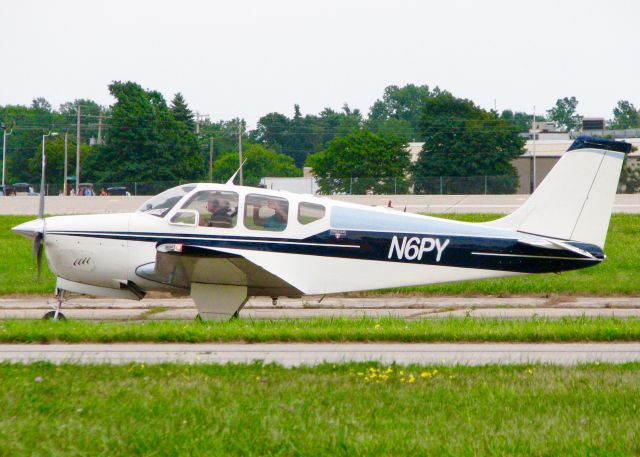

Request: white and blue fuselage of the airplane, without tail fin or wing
left=32, top=185, right=604, bottom=295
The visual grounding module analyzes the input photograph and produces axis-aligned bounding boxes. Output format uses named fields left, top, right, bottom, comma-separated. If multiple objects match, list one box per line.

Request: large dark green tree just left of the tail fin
left=413, top=92, right=525, bottom=193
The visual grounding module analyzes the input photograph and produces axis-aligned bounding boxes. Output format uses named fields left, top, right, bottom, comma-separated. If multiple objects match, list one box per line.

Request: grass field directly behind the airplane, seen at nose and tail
left=0, top=214, right=640, bottom=295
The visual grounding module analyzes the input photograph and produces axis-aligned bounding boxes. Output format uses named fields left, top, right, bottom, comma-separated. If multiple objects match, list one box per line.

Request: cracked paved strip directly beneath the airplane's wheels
left=5, top=296, right=640, bottom=320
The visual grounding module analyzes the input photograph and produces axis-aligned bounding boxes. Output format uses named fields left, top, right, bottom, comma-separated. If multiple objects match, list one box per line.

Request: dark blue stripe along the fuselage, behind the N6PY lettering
left=48, top=230, right=604, bottom=274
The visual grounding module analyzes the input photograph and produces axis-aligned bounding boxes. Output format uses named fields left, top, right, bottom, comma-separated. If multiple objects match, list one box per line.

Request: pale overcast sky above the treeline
left=0, top=0, right=640, bottom=126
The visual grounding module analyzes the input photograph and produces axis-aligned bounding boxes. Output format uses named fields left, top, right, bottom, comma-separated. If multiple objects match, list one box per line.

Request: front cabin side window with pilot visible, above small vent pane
left=182, top=190, right=239, bottom=228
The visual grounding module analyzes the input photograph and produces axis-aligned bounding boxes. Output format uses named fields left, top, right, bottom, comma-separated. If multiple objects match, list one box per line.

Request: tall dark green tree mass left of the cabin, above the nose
left=89, top=81, right=205, bottom=182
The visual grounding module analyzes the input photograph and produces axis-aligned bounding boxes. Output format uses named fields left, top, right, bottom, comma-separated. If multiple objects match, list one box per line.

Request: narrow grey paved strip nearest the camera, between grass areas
left=5, top=343, right=640, bottom=367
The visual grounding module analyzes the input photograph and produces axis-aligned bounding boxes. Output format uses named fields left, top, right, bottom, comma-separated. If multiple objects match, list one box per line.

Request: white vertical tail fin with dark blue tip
left=487, top=137, right=631, bottom=248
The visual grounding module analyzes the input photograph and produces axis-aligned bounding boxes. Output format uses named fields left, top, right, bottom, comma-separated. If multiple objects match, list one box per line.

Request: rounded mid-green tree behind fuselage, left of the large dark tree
left=307, top=128, right=411, bottom=194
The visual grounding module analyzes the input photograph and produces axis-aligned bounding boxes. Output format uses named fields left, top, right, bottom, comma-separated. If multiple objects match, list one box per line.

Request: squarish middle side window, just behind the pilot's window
left=244, top=194, right=289, bottom=232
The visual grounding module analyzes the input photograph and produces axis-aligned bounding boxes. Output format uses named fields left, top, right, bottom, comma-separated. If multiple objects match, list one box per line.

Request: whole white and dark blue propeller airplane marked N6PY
left=13, top=137, right=631, bottom=320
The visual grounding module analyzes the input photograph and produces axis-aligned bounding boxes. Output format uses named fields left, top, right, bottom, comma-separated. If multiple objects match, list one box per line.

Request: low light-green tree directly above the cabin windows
left=213, top=143, right=302, bottom=186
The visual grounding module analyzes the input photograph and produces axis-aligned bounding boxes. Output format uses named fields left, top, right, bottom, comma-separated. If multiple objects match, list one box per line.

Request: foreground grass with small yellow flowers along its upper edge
left=0, top=364, right=640, bottom=457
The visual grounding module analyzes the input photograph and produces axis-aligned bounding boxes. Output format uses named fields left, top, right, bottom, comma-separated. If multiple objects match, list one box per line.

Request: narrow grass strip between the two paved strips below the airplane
left=0, top=317, right=640, bottom=343
